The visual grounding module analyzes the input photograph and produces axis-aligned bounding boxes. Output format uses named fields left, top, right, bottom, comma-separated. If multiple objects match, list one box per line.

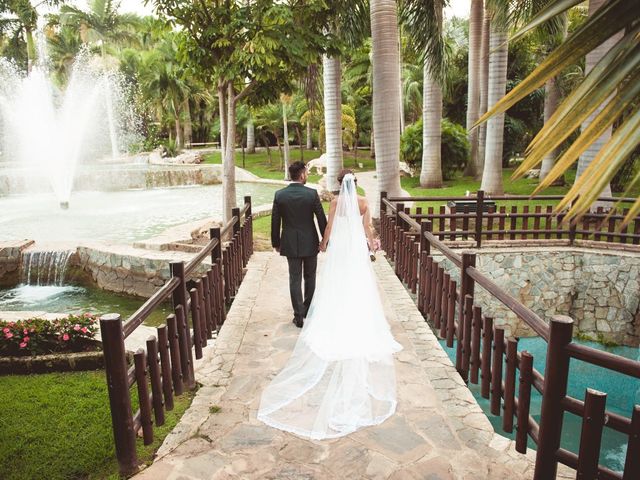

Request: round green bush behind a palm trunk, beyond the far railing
left=400, top=118, right=469, bottom=180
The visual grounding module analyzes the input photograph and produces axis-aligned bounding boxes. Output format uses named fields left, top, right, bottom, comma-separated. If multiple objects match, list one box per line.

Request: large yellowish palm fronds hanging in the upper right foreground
left=480, top=0, right=640, bottom=220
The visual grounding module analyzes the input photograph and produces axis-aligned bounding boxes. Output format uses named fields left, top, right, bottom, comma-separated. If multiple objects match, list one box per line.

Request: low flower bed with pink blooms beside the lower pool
left=0, top=313, right=98, bottom=356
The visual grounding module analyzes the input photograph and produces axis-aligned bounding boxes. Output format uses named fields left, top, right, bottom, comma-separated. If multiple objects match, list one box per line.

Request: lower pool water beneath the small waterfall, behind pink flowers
left=0, top=284, right=173, bottom=326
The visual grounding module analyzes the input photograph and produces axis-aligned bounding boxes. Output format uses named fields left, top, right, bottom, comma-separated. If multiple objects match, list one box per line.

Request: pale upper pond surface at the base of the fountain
left=0, top=183, right=281, bottom=244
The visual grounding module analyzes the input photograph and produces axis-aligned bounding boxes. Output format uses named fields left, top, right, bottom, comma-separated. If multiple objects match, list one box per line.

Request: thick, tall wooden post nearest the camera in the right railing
left=533, top=315, right=573, bottom=480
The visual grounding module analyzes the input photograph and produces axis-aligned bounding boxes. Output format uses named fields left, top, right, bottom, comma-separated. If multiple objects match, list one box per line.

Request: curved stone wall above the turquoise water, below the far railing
left=434, top=247, right=640, bottom=346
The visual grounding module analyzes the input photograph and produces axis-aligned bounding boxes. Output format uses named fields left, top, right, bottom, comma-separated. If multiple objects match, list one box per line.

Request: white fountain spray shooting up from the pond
left=0, top=41, right=134, bottom=209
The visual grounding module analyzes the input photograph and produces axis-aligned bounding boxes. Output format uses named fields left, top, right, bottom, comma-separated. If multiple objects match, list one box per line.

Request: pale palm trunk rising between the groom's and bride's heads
left=322, top=55, right=343, bottom=192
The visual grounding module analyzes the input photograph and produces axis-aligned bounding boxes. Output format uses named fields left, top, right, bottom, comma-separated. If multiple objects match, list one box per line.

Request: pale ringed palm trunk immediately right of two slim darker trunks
left=481, top=23, right=509, bottom=195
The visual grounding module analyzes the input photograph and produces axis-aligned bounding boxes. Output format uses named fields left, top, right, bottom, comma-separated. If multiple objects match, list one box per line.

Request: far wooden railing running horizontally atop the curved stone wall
left=385, top=190, right=640, bottom=248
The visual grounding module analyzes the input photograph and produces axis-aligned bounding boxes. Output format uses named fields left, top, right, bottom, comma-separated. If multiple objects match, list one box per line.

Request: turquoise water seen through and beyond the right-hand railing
left=440, top=337, right=640, bottom=471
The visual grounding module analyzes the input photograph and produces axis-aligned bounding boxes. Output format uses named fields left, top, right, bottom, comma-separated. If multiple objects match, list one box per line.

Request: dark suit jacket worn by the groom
left=271, top=183, right=327, bottom=257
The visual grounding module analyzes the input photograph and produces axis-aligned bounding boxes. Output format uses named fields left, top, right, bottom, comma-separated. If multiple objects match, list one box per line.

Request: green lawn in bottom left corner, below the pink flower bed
left=0, top=371, right=193, bottom=480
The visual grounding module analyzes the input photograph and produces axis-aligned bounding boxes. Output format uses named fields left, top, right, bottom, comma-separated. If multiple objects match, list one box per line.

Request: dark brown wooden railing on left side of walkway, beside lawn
left=100, top=197, right=253, bottom=474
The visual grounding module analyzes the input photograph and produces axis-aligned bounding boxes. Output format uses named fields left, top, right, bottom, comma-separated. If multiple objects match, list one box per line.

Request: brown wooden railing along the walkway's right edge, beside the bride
left=380, top=193, right=640, bottom=480
